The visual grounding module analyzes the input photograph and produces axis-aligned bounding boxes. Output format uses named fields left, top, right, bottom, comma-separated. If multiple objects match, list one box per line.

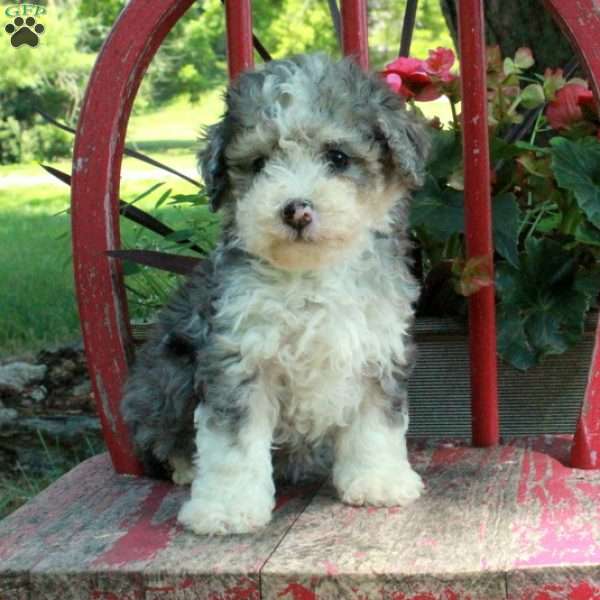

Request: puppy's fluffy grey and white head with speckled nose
left=201, top=55, right=427, bottom=270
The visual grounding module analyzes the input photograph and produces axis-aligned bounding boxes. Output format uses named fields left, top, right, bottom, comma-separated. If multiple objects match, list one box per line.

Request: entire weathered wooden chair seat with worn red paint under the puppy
left=0, top=436, right=600, bottom=600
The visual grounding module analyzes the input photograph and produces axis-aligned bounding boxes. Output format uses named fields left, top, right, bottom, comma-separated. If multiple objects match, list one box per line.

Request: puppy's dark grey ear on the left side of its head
left=199, top=117, right=230, bottom=212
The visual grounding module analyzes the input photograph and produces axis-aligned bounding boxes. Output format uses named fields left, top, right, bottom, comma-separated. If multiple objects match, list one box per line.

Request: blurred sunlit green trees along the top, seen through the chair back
left=0, top=0, right=452, bottom=164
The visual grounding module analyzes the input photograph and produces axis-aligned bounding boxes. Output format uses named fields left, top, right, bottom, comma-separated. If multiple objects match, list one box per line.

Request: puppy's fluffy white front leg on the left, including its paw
left=178, top=382, right=275, bottom=535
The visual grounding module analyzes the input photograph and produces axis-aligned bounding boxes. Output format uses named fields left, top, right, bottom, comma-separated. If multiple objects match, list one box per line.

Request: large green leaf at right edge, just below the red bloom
left=550, top=137, right=600, bottom=227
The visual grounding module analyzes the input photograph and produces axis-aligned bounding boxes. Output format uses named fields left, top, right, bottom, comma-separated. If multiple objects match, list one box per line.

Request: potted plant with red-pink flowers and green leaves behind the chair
left=382, top=47, right=600, bottom=369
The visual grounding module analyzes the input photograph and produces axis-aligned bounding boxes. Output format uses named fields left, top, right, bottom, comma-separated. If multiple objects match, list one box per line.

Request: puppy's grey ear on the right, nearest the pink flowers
left=375, top=93, right=430, bottom=188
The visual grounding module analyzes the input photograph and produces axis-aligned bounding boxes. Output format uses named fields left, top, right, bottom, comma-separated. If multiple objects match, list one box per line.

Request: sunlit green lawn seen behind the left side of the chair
left=0, top=90, right=222, bottom=356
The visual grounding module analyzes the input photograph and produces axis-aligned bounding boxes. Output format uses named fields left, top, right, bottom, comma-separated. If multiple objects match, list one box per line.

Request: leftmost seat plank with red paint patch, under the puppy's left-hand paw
left=0, top=455, right=315, bottom=600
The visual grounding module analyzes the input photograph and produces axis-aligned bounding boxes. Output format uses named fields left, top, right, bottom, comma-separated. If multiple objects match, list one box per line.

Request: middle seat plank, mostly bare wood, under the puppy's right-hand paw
left=262, top=445, right=522, bottom=600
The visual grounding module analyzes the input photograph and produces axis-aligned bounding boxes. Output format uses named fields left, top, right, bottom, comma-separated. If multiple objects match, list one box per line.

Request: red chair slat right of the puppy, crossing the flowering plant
left=458, top=0, right=500, bottom=446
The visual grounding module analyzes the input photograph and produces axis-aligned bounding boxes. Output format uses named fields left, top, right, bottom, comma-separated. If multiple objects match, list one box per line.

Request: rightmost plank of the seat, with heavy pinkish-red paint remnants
left=507, top=437, right=600, bottom=600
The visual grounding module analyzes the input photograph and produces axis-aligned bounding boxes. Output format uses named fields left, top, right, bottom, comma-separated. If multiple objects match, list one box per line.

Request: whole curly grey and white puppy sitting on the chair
left=123, top=55, right=427, bottom=534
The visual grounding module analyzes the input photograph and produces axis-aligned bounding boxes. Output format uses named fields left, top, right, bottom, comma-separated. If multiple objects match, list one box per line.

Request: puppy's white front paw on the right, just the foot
left=333, top=463, right=425, bottom=506
